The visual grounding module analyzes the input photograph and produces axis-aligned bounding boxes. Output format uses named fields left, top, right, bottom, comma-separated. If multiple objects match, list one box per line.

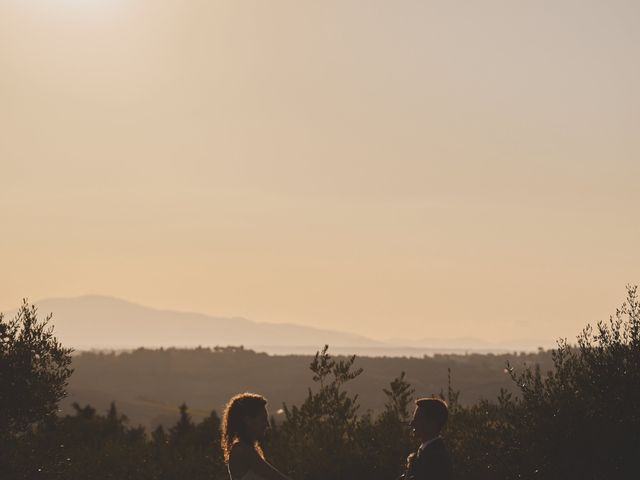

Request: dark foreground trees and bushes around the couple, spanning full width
left=0, top=287, right=640, bottom=480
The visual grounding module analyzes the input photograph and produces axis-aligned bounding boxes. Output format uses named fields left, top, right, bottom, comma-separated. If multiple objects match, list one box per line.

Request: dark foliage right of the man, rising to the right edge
left=448, top=287, right=640, bottom=480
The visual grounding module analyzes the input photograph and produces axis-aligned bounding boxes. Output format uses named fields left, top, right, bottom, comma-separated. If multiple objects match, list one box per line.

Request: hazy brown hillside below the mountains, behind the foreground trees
left=61, top=347, right=552, bottom=428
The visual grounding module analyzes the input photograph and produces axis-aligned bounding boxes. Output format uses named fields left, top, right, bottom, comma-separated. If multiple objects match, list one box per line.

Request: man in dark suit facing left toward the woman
left=400, top=397, right=452, bottom=480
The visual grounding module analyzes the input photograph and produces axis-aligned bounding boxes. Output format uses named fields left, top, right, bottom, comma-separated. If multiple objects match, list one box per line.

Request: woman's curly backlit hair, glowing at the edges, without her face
left=220, top=392, right=267, bottom=464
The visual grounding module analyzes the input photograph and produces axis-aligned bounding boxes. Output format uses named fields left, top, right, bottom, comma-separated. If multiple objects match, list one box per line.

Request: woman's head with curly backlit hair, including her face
left=220, top=393, right=269, bottom=463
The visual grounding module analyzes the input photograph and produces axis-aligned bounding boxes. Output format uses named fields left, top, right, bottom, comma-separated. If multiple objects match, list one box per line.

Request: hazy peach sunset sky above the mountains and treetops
left=0, top=0, right=640, bottom=340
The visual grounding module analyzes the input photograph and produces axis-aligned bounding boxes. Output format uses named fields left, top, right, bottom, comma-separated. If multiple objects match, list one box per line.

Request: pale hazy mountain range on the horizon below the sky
left=5, top=295, right=546, bottom=356
